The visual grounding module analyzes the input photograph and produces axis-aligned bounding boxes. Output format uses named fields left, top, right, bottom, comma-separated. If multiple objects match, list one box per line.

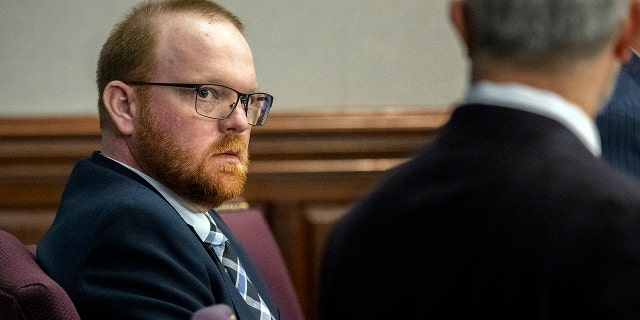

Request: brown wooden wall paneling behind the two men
left=0, top=107, right=449, bottom=320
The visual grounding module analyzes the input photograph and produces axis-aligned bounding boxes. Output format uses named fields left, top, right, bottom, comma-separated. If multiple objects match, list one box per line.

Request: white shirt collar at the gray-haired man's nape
left=464, top=81, right=601, bottom=156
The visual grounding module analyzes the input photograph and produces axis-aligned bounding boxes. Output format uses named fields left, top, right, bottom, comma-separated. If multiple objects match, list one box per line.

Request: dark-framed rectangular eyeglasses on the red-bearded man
left=125, top=81, right=273, bottom=126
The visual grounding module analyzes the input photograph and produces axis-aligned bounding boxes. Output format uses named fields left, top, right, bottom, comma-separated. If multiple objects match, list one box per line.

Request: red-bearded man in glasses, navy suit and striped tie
left=37, top=0, right=280, bottom=320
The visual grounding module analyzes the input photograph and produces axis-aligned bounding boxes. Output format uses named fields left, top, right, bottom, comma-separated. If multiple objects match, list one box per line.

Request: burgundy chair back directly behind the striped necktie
left=219, top=208, right=304, bottom=320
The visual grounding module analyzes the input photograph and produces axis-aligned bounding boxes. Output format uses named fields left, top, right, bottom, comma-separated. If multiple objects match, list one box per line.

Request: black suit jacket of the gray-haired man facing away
left=319, top=105, right=640, bottom=320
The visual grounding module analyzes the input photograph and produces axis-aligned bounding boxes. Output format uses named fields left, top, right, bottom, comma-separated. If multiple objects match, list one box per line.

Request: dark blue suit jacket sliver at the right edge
left=596, top=54, right=640, bottom=179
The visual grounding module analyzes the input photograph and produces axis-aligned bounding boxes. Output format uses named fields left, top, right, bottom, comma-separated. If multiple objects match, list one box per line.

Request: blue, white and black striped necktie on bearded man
left=204, top=214, right=274, bottom=320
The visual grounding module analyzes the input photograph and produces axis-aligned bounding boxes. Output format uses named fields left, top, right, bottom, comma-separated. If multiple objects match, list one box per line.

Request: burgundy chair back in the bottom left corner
left=0, top=230, right=80, bottom=320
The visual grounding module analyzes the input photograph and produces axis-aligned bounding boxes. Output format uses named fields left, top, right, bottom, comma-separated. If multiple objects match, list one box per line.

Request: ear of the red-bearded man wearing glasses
left=102, top=80, right=137, bottom=135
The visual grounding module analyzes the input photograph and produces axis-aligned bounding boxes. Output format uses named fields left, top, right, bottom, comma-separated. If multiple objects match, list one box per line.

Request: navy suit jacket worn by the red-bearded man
left=37, top=152, right=278, bottom=320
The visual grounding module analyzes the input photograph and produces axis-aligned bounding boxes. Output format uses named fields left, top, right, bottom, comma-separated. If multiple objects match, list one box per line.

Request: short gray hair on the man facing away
left=464, top=0, right=630, bottom=67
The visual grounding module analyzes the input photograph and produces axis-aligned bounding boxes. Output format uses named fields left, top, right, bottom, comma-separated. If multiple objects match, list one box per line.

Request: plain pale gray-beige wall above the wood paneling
left=0, top=0, right=467, bottom=116
